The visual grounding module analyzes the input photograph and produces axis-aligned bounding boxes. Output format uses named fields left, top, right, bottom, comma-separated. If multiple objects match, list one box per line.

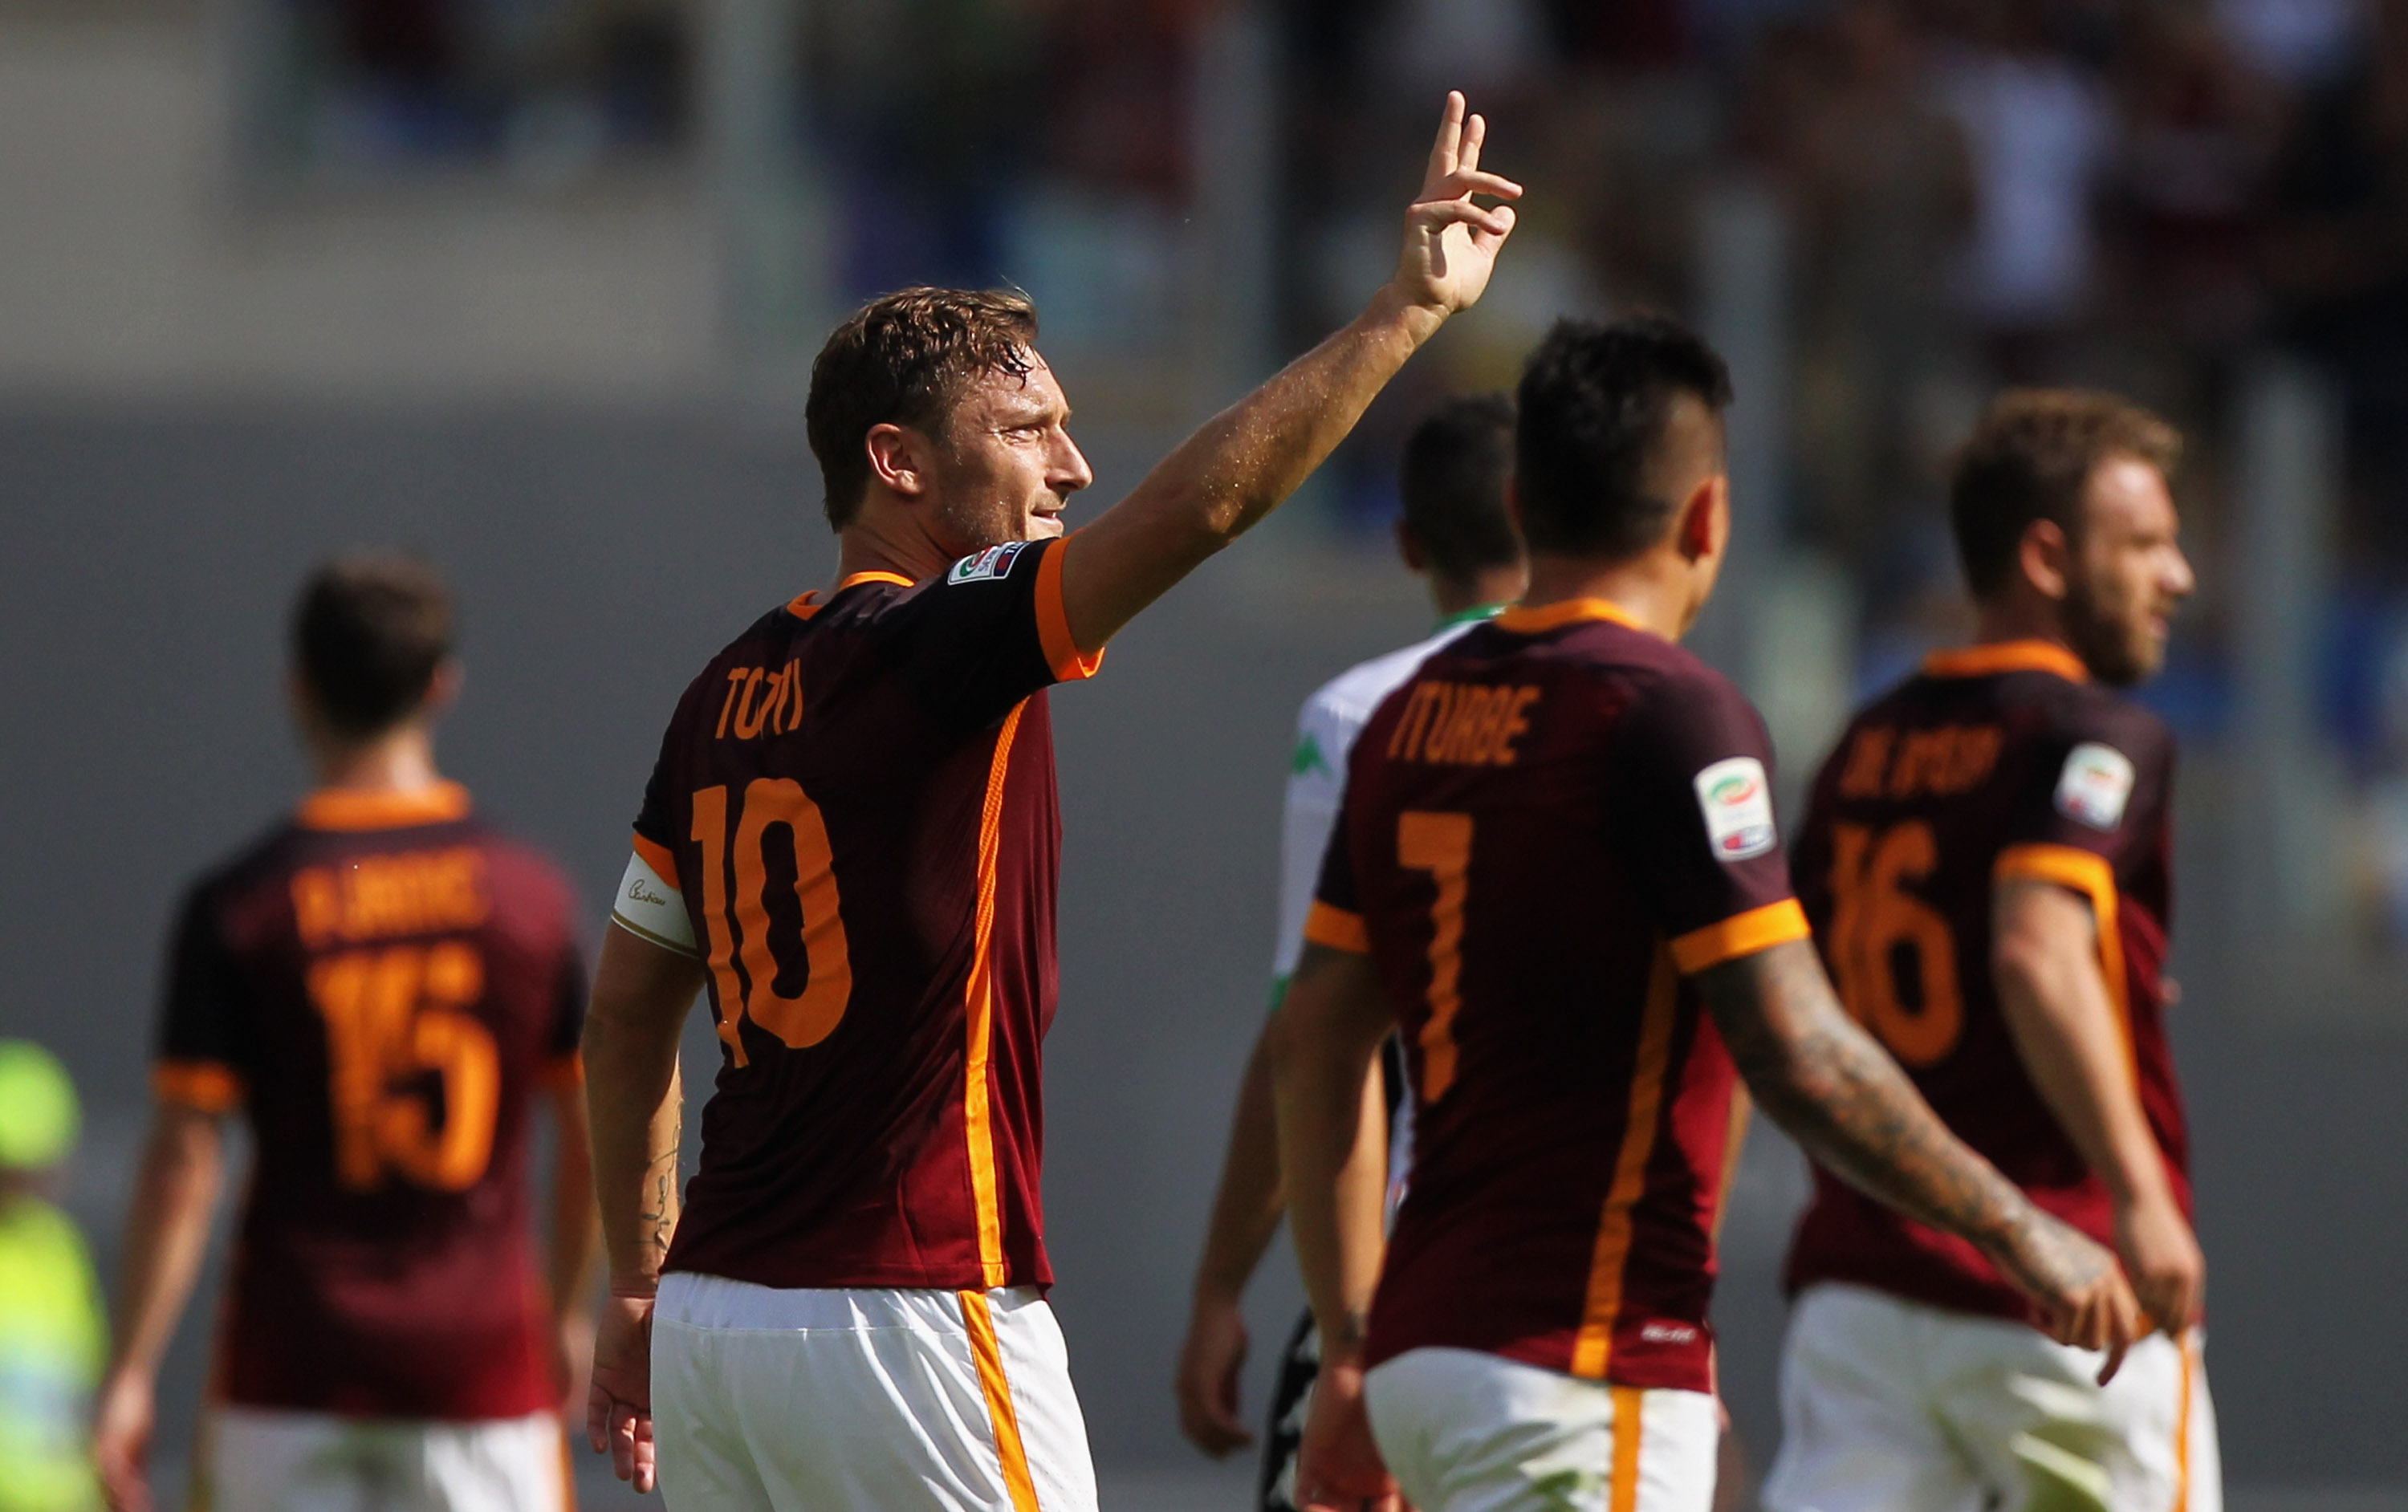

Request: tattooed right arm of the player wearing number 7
left=1695, top=939, right=2138, bottom=1380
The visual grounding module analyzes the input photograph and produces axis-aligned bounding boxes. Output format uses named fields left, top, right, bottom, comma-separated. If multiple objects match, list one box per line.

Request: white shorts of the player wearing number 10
left=653, top=1271, right=1096, bottom=1512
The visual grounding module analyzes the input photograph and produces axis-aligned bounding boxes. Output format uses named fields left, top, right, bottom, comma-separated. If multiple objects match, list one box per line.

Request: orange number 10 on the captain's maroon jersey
left=694, top=778, right=852, bottom=1067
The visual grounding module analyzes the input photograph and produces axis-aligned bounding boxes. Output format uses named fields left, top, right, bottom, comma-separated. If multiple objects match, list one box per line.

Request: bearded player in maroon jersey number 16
left=1765, top=390, right=2223, bottom=1512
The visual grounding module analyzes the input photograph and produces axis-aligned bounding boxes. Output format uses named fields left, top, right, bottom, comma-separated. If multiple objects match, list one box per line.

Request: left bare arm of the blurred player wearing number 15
left=92, top=1103, right=226, bottom=1512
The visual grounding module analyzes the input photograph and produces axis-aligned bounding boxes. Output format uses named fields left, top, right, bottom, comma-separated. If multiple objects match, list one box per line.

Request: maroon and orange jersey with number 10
left=636, top=542, right=1100, bottom=1288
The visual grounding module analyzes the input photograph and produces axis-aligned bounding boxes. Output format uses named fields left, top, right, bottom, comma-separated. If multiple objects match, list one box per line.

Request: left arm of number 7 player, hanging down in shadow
left=1271, top=944, right=1401, bottom=1512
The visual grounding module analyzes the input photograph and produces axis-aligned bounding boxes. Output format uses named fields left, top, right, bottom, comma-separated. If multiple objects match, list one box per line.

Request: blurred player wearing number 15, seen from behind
left=94, top=556, right=595, bottom=1512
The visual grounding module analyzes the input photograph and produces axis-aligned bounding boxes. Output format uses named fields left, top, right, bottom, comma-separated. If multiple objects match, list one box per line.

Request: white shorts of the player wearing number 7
left=1363, top=1348, right=1722, bottom=1512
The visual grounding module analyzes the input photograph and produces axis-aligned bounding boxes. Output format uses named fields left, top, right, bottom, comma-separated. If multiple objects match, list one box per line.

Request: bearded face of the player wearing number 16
left=2064, top=457, right=2196, bottom=689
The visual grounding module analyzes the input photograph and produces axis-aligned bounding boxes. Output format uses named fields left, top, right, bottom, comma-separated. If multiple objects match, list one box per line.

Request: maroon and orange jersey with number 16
left=1789, top=640, right=2191, bottom=1319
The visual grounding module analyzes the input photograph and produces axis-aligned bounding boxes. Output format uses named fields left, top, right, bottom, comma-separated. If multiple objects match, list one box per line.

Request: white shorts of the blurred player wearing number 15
left=193, top=1406, right=571, bottom=1512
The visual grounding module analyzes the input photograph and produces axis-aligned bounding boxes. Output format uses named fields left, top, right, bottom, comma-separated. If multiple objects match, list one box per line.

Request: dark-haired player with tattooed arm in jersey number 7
left=1274, top=318, right=2136, bottom=1512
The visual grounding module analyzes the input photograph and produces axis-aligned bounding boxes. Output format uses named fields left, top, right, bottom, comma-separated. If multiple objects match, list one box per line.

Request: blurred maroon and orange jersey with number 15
left=154, top=785, right=585, bottom=1421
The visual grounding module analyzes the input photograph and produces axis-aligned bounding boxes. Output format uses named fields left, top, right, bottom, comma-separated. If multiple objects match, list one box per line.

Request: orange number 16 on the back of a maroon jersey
left=1830, top=819, right=1965, bottom=1067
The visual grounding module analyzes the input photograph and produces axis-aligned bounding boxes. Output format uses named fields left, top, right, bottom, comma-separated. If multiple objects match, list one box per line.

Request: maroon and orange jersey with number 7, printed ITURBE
left=1308, top=600, right=1806, bottom=1392
